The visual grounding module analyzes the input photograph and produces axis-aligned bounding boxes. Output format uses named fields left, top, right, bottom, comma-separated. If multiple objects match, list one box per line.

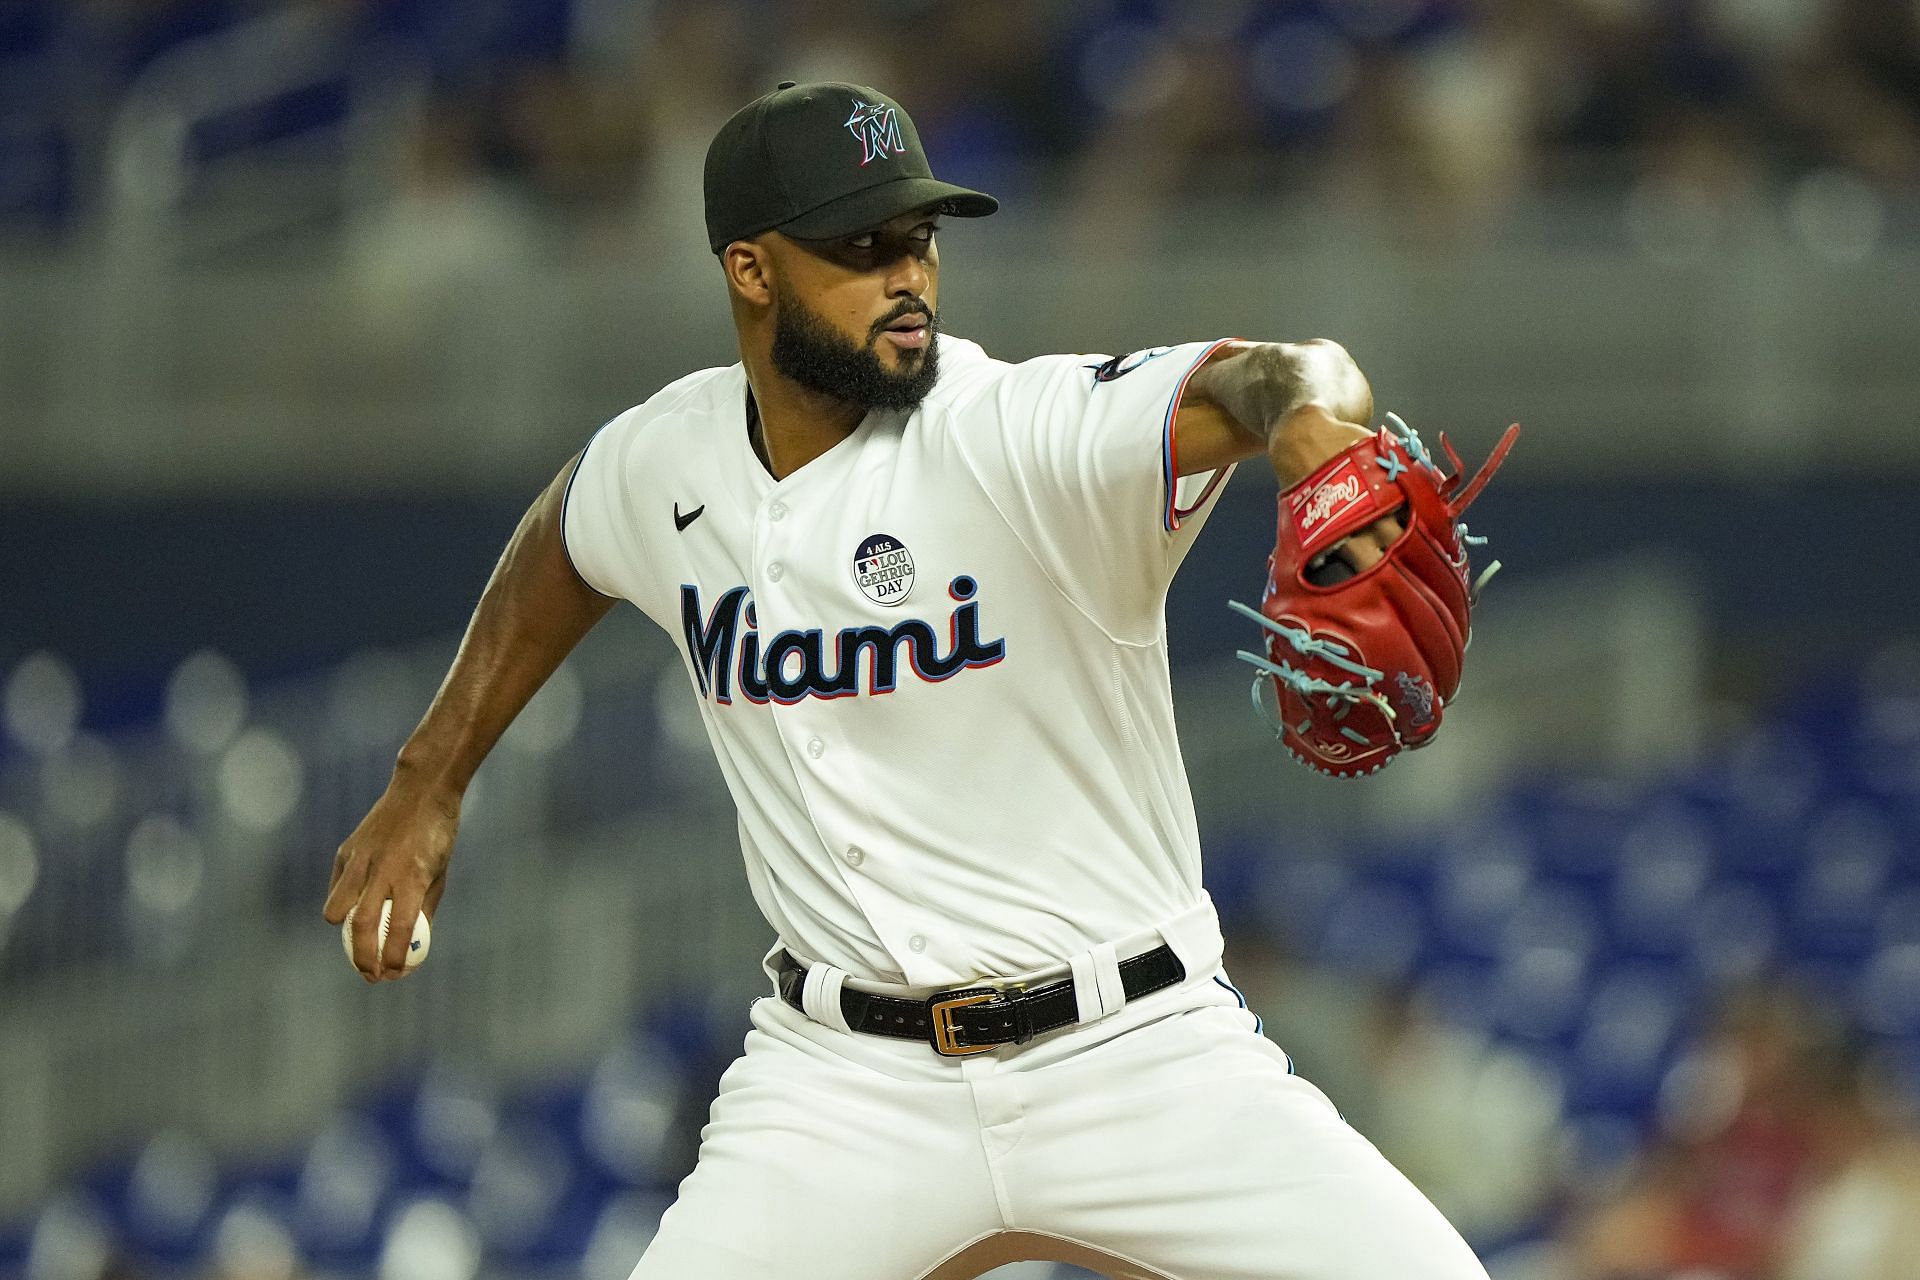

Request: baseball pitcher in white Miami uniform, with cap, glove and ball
left=324, top=83, right=1512, bottom=1280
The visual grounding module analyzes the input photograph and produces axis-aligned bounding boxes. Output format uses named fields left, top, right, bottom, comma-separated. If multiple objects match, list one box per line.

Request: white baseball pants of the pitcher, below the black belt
left=634, top=969, right=1486, bottom=1280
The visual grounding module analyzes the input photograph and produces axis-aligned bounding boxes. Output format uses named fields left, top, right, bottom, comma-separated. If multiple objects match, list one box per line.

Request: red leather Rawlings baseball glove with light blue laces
left=1229, top=415, right=1521, bottom=777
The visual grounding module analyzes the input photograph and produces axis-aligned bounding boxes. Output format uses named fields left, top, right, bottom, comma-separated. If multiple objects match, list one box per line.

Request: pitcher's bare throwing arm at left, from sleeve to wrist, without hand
left=394, top=459, right=612, bottom=796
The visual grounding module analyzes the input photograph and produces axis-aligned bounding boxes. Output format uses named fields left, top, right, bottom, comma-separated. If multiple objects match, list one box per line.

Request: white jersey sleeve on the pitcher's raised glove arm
left=954, top=340, right=1233, bottom=643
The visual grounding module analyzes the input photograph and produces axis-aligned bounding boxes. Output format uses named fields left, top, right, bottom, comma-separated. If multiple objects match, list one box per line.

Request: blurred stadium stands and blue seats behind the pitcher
left=0, top=0, right=1920, bottom=1280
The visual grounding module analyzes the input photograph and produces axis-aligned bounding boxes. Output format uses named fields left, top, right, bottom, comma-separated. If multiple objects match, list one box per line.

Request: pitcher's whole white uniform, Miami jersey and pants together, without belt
left=563, top=338, right=1486, bottom=1280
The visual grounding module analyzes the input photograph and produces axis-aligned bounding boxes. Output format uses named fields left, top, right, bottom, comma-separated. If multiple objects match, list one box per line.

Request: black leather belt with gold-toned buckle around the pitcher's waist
left=778, top=944, right=1187, bottom=1057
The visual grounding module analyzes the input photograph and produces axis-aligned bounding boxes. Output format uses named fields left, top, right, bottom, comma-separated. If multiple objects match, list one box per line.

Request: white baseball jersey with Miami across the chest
left=563, top=338, right=1231, bottom=986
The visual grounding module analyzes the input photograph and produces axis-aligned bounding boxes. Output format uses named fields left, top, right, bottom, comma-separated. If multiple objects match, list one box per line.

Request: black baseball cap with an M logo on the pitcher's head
left=707, top=81, right=1000, bottom=253
